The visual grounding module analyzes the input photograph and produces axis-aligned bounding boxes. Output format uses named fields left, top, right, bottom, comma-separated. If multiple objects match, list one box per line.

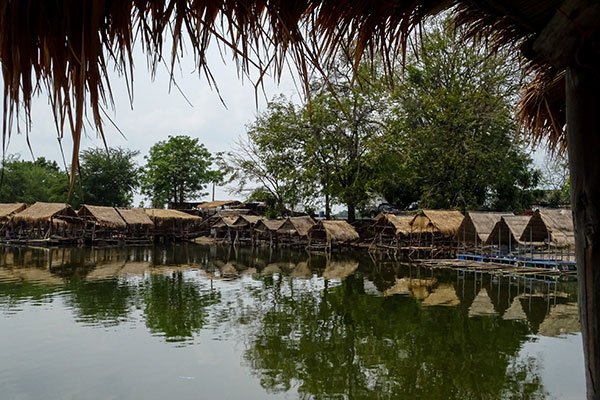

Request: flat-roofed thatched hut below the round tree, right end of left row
left=144, top=208, right=202, bottom=241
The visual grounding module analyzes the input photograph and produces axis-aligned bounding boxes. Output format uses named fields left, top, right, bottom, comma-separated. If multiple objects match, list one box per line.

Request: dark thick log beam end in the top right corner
left=533, top=0, right=600, bottom=69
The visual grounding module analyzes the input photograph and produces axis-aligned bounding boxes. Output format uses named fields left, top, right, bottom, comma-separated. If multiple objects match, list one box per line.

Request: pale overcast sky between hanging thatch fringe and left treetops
left=8, top=45, right=298, bottom=205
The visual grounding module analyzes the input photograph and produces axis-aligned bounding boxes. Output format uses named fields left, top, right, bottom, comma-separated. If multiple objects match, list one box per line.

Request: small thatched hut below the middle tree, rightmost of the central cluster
left=307, top=220, right=360, bottom=251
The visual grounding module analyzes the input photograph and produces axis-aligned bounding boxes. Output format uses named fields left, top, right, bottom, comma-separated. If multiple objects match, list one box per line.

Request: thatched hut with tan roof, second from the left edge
left=10, top=202, right=84, bottom=244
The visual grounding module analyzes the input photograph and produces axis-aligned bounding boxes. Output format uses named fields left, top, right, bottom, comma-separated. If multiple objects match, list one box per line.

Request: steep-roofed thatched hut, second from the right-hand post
left=485, top=215, right=531, bottom=256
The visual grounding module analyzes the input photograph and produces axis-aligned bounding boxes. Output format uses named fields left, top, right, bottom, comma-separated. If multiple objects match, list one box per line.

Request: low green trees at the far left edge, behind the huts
left=0, top=155, right=73, bottom=205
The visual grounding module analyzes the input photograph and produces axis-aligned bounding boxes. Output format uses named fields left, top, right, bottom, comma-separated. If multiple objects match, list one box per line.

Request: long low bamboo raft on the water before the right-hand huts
left=416, top=259, right=573, bottom=277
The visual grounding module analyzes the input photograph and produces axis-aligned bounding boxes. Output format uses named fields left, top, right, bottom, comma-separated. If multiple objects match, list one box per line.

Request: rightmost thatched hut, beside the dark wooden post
left=520, top=209, right=575, bottom=247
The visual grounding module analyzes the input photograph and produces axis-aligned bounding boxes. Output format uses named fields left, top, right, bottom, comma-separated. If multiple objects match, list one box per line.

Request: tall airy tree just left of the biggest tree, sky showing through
left=304, top=62, right=393, bottom=221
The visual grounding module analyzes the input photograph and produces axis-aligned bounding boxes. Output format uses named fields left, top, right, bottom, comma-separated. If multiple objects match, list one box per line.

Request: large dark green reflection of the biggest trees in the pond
left=245, top=274, right=545, bottom=399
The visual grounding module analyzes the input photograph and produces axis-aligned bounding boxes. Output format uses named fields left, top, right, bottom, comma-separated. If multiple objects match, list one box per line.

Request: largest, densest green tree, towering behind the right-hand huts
left=378, top=21, right=539, bottom=210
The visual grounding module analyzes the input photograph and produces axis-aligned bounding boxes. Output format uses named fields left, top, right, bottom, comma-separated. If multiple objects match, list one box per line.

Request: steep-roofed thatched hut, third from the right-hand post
left=456, top=211, right=514, bottom=254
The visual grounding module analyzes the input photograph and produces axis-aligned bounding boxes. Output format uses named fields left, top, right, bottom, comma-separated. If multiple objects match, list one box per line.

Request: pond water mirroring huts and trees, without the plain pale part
left=0, top=245, right=579, bottom=399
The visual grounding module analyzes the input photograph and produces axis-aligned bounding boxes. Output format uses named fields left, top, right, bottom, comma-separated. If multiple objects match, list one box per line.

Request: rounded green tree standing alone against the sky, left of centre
left=142, top=135, right=222, bottom=207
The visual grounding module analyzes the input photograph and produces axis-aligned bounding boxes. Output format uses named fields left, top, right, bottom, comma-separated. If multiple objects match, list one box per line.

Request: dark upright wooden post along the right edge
left=566, top=65, right=600, bottom=399
